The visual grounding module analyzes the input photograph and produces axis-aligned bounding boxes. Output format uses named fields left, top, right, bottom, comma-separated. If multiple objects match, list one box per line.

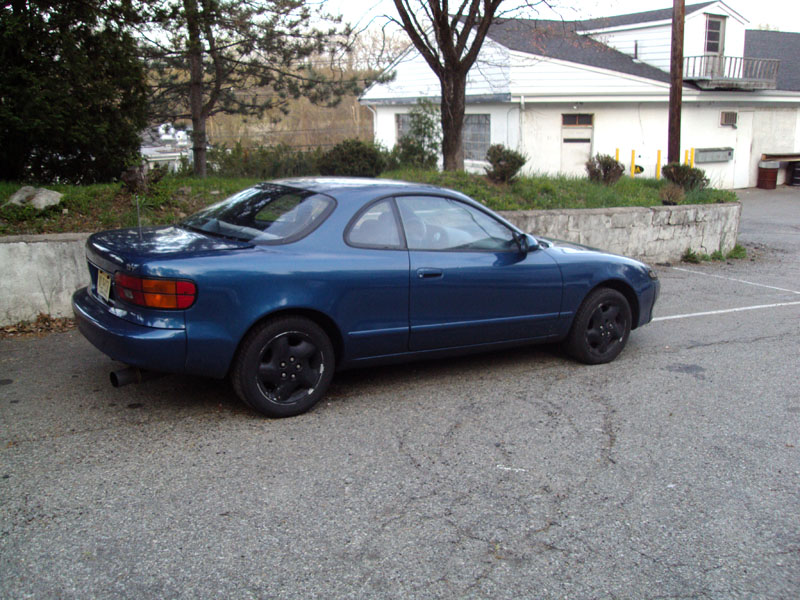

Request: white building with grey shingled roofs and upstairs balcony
left=361, top=1, right=800, bottom=188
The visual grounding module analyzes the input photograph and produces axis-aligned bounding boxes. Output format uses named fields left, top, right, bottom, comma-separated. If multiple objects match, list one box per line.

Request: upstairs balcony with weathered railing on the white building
left=683, top=56, right=781, bottom=90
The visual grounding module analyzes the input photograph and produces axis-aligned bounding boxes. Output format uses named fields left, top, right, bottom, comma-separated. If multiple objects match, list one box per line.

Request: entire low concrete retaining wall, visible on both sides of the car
left=0, top=204, right=741, bottom=325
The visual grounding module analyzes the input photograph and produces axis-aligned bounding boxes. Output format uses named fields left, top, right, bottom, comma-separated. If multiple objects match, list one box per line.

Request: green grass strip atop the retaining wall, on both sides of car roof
left=0, top=169, right=736, bottom=235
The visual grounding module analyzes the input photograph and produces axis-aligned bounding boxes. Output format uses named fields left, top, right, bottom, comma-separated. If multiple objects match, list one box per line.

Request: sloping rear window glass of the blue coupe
left=180, top=184, right=334, bottom=244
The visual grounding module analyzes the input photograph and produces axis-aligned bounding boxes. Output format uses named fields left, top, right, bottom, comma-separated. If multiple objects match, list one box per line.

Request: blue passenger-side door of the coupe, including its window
left=395, top=196, right=562, bottom=351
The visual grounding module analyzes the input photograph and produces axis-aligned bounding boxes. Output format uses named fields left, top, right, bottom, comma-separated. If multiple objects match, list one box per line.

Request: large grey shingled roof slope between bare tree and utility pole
left=488, top=19, right=669, bottom=83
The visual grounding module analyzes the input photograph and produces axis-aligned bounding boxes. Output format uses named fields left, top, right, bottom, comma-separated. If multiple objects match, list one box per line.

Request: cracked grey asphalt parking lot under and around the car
left=0, top=188, right=800, bottom=598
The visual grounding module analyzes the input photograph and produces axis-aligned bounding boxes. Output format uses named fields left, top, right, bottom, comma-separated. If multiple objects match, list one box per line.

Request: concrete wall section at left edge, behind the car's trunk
left=0, top=233, right=89, bottom=325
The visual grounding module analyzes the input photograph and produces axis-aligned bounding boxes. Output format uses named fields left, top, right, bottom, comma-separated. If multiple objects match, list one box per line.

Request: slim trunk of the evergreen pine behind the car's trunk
left=183, top=0, right=206, bottom=177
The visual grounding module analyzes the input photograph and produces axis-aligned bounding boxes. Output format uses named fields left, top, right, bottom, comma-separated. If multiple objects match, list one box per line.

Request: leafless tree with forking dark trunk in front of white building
left=390, top=0, right=549, bottom=171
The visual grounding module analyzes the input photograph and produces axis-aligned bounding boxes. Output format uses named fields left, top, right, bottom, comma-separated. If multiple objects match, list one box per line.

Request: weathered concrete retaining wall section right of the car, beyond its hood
left=501, top=203, right=742, bottom=263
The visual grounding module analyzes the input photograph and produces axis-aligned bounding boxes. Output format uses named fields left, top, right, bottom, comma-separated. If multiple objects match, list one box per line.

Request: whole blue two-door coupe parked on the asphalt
left=72, top=178, right=659, bottom=417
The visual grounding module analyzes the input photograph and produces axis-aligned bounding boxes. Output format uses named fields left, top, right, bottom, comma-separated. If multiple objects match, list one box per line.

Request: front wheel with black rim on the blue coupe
left=564, top=288, right=631, bottom=365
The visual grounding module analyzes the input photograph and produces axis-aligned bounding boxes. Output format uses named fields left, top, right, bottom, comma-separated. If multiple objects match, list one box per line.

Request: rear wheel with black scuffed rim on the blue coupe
left=231, top=317, right=335, bottom=418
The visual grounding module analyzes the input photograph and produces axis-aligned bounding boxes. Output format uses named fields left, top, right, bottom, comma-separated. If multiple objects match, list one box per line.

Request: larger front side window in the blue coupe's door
left=396, top=196, right=517, bottom=252
